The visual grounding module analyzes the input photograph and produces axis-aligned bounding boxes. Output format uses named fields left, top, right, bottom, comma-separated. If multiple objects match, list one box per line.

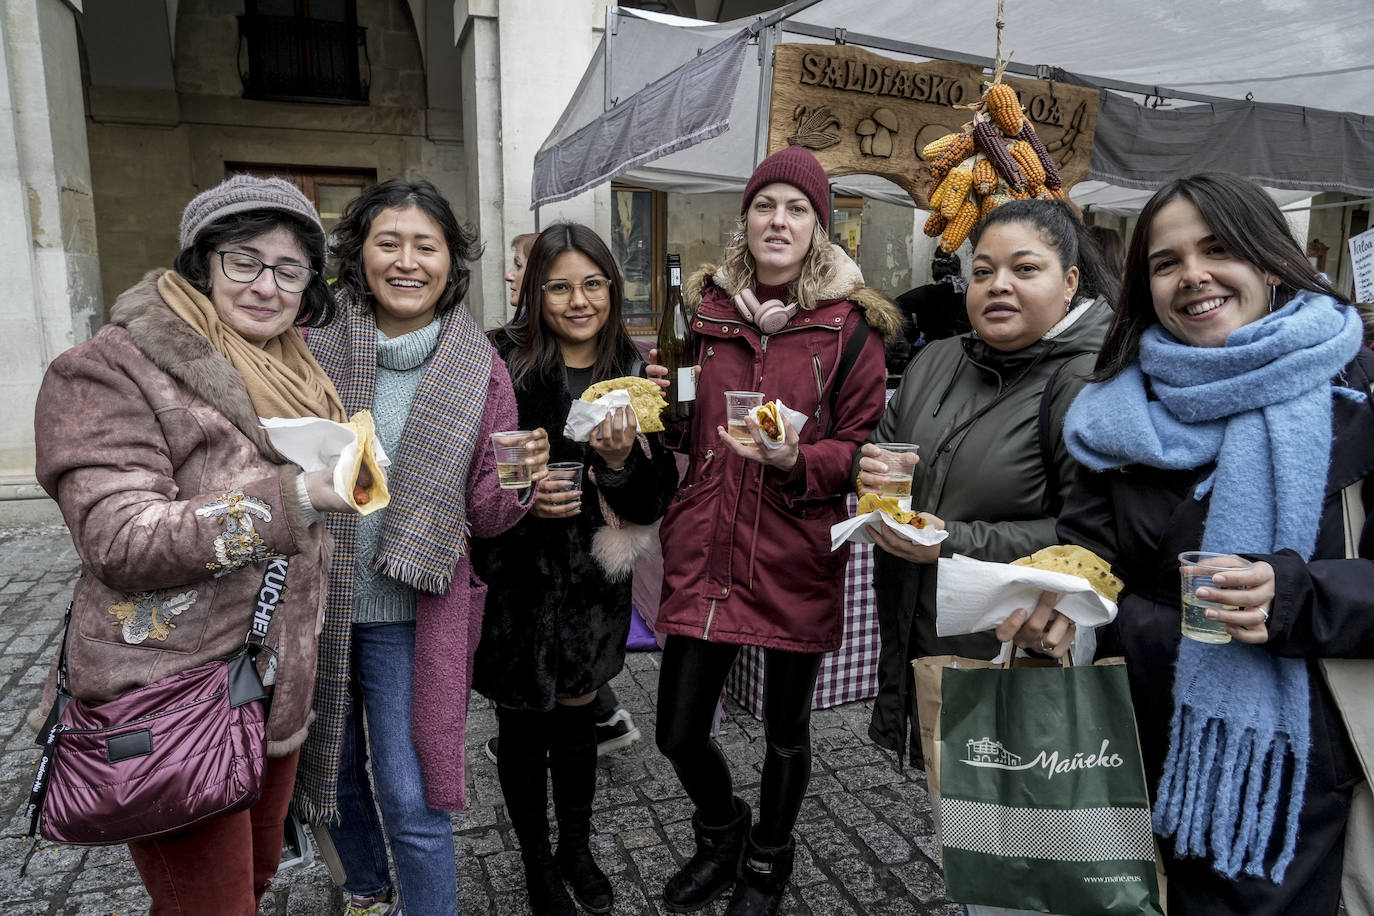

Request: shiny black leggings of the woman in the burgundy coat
left=657, top=636, right=822, bottom=846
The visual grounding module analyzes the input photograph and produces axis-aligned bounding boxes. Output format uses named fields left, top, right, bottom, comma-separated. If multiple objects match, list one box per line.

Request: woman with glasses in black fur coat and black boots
left=473, top=222, right=677, bottom=915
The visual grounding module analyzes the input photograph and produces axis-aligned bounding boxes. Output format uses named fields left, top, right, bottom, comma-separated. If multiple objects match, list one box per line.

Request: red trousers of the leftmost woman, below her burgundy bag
left=129, top=751, right=301, bottom=916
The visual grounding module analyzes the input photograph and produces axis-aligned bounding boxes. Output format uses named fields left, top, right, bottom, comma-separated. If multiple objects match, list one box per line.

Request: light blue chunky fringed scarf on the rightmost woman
left=1063, top=293, right=1364, bottom=883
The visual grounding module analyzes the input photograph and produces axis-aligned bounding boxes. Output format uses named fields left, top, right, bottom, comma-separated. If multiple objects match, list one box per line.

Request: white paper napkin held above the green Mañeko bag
left=936, top=553, right=1116, bottom=645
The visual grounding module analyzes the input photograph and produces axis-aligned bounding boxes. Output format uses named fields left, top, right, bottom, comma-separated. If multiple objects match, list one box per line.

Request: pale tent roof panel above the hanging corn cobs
left=793, top=0, right=1374, bottom=114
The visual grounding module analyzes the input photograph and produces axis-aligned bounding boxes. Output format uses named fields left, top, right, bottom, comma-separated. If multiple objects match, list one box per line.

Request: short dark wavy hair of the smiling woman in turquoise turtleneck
left=330, top=179, right=482, bottom=316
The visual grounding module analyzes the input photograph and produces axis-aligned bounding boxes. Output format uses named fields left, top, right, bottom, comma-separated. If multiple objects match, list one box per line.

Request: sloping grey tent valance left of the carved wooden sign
left=530, top=29, right=749, bottom=209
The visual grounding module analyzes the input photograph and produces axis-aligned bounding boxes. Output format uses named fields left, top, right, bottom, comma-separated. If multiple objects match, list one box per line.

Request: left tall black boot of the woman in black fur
left=496, top=706, right=577, bottom=916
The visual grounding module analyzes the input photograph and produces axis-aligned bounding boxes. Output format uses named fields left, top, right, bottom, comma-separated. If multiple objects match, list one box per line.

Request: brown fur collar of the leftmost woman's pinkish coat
left=110, top=269, right=283, bottom=464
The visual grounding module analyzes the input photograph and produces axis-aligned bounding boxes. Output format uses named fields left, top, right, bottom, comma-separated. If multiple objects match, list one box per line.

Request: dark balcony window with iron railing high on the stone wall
left=238, top=0, right=372, bottom=104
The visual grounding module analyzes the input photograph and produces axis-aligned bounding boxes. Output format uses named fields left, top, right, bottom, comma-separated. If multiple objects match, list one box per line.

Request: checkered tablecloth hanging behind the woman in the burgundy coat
left=725, top=496, right=878, bottom=718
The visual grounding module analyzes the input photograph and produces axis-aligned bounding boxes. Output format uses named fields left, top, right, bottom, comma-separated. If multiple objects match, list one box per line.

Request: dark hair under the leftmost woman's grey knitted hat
left=172, top=210, right=335, bottom=328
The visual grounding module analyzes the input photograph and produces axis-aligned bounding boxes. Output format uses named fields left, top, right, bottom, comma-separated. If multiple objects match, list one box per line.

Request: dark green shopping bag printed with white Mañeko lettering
left=940, top=663, right=1161, bottom=916
